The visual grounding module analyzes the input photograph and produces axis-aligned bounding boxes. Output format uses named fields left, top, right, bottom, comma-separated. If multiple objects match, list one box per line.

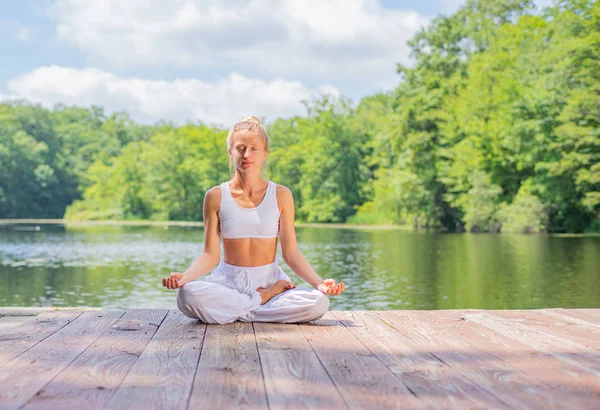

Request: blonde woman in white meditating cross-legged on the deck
left=163, top=117, right=344, bottom=324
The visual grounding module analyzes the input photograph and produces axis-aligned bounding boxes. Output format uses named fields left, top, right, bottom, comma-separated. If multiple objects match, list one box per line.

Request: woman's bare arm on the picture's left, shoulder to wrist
left=178, top=186, right=221, bottom=286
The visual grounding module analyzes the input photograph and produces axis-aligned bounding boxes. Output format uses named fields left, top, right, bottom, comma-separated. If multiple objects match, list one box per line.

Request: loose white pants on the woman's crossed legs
left=177, top=261, right=329, bottom=324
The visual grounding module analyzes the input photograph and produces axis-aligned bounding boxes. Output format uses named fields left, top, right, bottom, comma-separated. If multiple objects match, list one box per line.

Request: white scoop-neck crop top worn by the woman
left=219, top=181, right=279, bottom=239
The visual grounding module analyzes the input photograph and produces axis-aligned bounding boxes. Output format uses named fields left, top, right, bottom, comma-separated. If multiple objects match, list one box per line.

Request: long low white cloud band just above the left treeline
left=4, top=66, right=339, bottom=126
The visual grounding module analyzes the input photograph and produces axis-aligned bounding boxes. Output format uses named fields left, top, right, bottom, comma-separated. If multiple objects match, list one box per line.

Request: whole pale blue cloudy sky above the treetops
left=0, top=0, right=551, bottom=128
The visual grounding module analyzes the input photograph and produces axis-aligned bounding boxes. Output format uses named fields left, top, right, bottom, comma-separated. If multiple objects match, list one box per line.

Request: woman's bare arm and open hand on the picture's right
left=277, top=185, right=343, bottom=295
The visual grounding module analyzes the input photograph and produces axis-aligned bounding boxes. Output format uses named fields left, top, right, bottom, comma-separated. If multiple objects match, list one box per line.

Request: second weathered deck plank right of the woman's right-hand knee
left=377, top=311, right=576, bottom=408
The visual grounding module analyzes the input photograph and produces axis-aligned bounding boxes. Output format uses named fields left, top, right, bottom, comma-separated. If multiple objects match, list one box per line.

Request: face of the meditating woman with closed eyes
left=229, top=131, right=268, bottom=172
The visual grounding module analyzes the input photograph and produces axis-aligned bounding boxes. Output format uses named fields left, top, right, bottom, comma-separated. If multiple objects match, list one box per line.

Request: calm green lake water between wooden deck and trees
left=0, top=225, right=600, bottom=309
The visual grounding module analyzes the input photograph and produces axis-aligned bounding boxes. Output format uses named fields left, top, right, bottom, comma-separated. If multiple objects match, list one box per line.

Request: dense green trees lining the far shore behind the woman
left=0, top=0, right=600, bottom=232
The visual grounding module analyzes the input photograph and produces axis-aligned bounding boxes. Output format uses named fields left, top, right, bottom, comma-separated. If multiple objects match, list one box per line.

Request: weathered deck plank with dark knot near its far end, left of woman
left=23, top=309, right=167, bottom=409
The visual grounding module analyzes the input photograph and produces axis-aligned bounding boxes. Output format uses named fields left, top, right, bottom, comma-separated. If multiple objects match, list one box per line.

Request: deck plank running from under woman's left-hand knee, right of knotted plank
left=106, top=310, right=206, bottom=409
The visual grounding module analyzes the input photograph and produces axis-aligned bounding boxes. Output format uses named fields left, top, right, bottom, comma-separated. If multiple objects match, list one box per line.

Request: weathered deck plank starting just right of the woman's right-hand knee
left=332, top=310, right=508, bottom=408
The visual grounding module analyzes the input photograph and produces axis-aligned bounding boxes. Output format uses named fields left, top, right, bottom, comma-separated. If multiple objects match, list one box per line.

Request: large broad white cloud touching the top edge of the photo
left=52, top=0, right=428, bottom=88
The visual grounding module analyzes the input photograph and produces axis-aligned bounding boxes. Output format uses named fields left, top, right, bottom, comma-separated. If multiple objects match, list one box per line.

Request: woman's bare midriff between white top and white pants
left=223, top=238, right=277, bottom=267
